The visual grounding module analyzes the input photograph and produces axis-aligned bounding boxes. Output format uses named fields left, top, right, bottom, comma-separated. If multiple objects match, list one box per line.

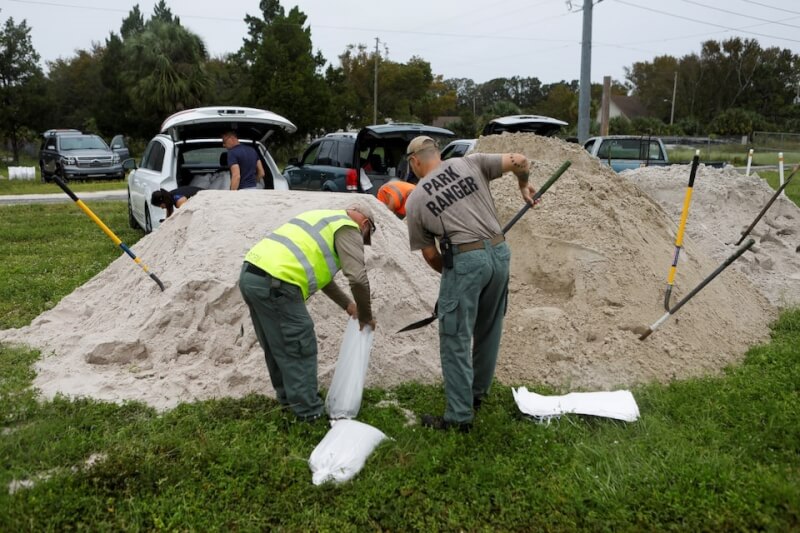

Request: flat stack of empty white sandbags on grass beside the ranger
left=511, top=387, right=639, bottom=422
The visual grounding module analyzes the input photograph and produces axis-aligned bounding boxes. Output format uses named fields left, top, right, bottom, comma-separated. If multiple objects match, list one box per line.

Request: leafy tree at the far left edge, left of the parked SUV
left=0, top=12, right=42, bottom=162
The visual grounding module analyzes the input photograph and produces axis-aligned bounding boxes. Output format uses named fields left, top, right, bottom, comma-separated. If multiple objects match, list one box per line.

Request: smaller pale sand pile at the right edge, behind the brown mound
left=622, top=165, right=800, bottom=307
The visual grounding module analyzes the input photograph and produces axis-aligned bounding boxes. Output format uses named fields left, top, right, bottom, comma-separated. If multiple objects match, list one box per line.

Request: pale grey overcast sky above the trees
left=0, top=0, right=800, bottom=83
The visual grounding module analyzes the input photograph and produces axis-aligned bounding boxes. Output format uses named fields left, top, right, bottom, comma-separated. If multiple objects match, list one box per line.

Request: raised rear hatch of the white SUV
left=161, top=106, right=297, bottom=142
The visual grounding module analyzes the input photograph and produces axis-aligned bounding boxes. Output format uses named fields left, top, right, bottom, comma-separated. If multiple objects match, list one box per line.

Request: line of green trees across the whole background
left=0, top=0, right=800, bottom=160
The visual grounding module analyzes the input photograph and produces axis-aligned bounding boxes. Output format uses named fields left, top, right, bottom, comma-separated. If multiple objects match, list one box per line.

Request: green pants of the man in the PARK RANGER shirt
left=438, top=241, right=511, bottom=424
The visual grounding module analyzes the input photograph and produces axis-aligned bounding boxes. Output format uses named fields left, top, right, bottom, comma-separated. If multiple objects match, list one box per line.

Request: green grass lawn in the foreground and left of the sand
left=0, top=192, right=800, bottom=531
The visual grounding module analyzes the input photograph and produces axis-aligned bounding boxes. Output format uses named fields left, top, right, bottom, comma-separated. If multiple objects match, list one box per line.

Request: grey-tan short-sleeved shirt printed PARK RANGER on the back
left=406, top=154, right=503, bottom=251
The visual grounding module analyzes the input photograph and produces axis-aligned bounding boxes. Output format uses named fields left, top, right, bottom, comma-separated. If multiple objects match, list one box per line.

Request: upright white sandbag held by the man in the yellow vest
left=325, top=318, right=375, bottom=418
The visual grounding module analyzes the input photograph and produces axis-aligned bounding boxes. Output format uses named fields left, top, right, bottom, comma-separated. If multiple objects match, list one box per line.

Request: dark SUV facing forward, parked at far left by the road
left=39, top=130, right=125, bottom=182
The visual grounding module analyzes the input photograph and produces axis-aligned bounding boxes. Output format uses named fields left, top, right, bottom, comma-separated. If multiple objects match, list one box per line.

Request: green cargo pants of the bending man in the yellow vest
left=239, top=263, right=323, bottom=419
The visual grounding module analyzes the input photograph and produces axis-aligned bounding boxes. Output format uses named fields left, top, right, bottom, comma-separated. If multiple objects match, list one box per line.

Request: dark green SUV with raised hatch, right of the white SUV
left=283, top=123, right=455, bottom=194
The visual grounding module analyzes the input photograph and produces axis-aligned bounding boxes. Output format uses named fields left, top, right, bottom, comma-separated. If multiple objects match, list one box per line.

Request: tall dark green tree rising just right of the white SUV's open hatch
left=238, top=0, right=331, bottom=135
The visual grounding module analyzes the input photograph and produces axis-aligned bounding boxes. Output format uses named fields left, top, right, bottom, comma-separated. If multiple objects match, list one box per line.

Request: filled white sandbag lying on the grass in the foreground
left=308, top=420, right=387, bottom=485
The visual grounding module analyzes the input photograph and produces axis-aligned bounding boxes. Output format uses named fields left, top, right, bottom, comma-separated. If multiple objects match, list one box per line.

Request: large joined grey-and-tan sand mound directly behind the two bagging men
left=0, top=134, right=774, bottom=408
